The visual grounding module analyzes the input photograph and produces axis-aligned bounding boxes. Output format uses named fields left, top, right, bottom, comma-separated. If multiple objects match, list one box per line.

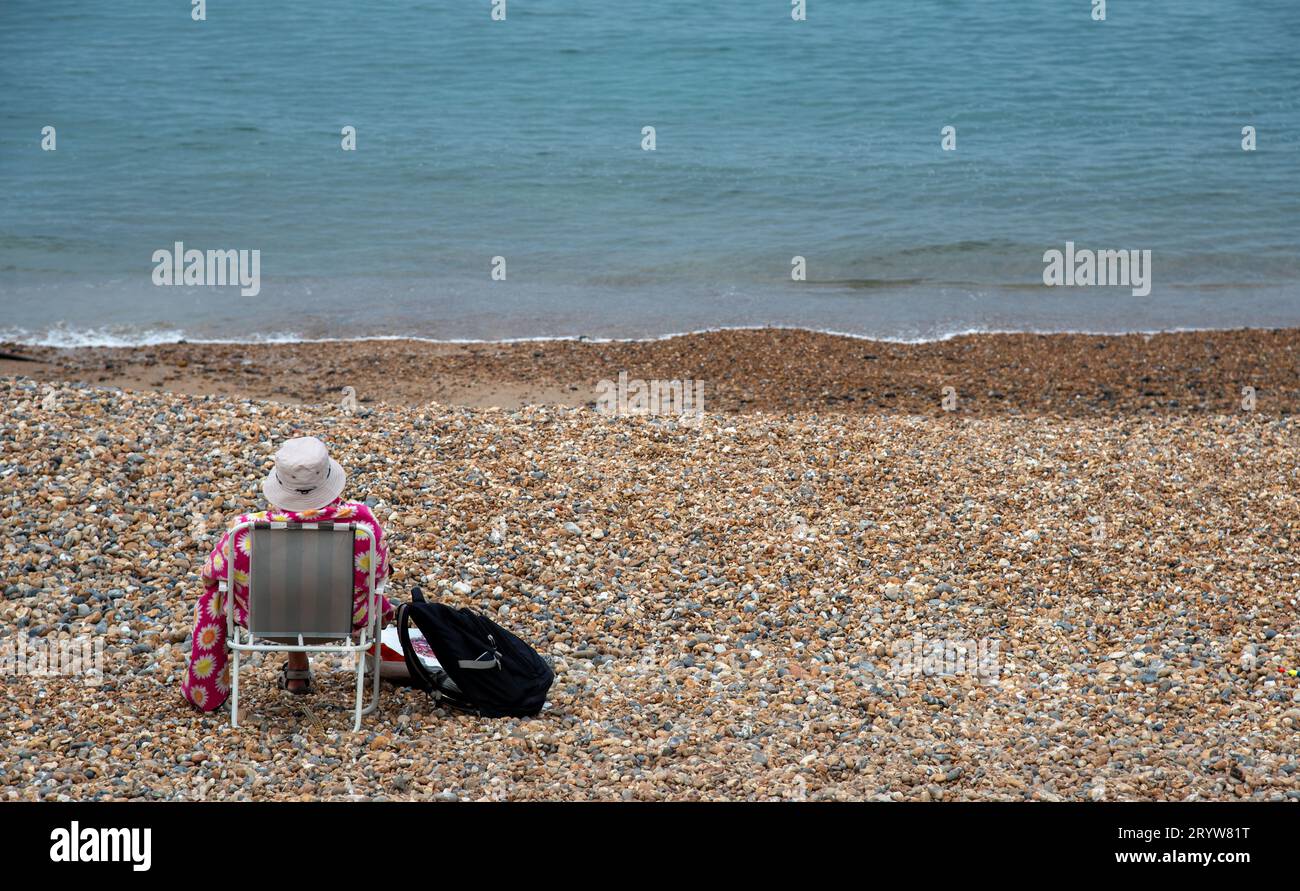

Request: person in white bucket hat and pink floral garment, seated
left=181, top=436, right=393, bottom=711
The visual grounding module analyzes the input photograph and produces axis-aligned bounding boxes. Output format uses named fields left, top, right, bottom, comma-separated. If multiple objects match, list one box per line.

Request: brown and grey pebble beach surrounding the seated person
left=0, top=332, right=1300, bottom=801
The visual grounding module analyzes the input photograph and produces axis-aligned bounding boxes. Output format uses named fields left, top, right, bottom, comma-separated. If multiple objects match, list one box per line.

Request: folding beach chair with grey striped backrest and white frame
left=221, top=520, right=382, bottom=730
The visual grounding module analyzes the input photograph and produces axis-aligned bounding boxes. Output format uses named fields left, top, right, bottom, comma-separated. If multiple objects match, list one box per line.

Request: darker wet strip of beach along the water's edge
left=0, top=329, right=1300, bottom=416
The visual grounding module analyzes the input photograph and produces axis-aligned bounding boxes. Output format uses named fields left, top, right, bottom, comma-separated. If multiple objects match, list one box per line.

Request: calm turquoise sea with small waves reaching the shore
left=0, top=0, right=1300, bottom=343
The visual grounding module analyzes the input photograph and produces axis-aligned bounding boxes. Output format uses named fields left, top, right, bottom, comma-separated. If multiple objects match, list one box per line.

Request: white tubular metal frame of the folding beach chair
left=220, top=520, right=386, bottom=731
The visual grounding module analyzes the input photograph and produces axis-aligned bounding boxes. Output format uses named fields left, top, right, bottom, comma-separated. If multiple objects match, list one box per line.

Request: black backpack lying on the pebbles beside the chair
left=398, top=588, right=555, bottom=718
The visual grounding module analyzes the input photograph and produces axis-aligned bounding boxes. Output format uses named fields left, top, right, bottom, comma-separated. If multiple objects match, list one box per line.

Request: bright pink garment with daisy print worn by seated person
left=181, top=499, right=393, bottom=711
